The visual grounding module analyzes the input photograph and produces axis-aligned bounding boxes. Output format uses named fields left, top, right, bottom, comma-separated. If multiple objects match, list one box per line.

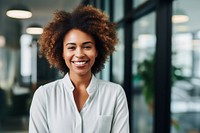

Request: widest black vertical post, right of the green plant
left=154, top=0, right=172, bottom=133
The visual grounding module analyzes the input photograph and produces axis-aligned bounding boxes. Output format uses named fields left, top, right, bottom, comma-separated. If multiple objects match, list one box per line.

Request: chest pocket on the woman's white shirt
left=96, top=115, right=112, bottom=133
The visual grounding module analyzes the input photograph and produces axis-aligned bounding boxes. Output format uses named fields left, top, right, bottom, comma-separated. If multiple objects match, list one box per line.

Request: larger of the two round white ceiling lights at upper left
left=6, top=5, right=32, bottom=19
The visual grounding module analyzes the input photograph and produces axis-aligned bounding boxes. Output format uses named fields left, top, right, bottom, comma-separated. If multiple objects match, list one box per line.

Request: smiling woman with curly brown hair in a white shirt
left=29, top=6, right=129, bottom=133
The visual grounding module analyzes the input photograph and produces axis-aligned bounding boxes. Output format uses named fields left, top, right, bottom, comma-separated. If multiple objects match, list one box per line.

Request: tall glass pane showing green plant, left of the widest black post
left=132, top=13, right=156, bottom=133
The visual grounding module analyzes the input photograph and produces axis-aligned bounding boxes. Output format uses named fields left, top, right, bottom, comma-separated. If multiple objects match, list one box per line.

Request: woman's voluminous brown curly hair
left=38, top=5, right=118, bottom=73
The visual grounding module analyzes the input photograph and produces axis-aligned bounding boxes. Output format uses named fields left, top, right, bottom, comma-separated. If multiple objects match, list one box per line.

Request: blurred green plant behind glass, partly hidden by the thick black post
left=137, top=55, right=186, bottom=129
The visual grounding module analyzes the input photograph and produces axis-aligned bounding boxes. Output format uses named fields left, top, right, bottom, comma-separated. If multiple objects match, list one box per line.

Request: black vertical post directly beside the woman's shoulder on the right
left=123, top=0, right=133, bottom=132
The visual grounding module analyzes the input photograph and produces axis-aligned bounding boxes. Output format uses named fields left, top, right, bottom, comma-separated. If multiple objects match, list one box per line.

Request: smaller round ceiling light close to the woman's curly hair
left=26, top=24, right=43, bottom=35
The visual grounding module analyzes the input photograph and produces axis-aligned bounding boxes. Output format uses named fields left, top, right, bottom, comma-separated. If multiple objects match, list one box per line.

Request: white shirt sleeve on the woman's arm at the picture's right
left=111, top=86, right=130, bottom=133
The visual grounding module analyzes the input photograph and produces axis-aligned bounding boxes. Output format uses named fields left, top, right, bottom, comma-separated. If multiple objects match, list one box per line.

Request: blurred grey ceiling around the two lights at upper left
left=0, top=0, right=82, bottom=45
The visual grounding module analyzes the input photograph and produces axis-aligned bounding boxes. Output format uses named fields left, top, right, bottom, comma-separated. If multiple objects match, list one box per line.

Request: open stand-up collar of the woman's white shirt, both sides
left=63, top=73, right=98, bottom=96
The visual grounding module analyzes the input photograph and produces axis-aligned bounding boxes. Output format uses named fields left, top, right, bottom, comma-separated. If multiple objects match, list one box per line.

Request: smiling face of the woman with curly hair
left=63, top=29, right=98, bottom=75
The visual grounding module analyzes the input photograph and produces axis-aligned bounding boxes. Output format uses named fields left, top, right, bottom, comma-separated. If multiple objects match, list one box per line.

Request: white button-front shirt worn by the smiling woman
left=29, top=74, right=129, bottom=133
